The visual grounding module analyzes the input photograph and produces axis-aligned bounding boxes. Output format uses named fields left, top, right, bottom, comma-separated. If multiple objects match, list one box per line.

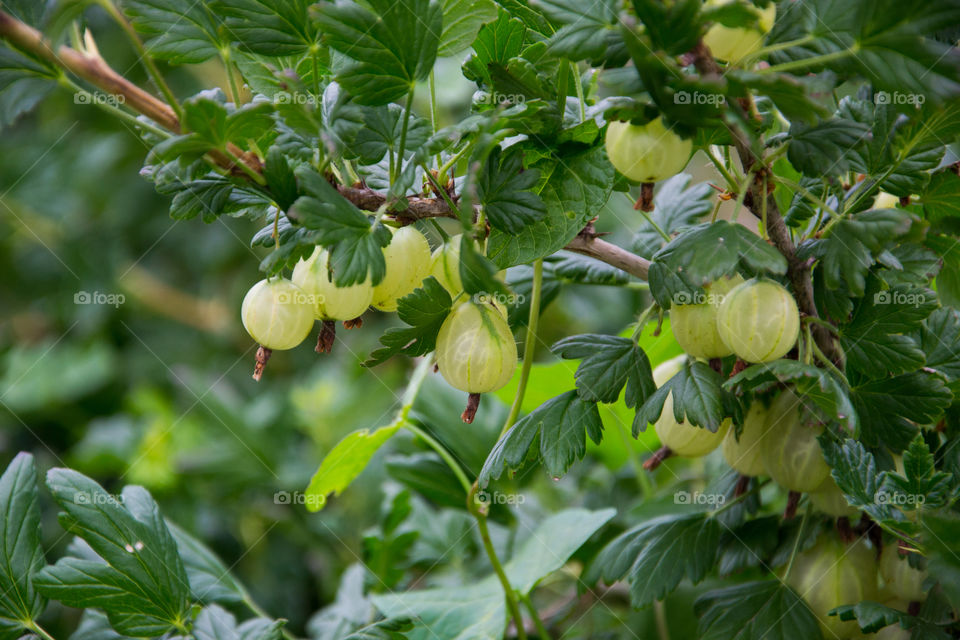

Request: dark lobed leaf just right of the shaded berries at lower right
left=820, top=438, right=894, bottom=521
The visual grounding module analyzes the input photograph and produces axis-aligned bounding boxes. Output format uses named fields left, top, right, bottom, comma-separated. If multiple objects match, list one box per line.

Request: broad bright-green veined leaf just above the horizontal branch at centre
left=487, top=147, right=613, bottom=268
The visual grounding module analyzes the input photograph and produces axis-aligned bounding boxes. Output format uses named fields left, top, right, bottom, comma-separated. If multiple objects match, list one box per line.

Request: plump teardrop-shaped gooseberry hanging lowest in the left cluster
left=437, top=300, right=517, bottom=393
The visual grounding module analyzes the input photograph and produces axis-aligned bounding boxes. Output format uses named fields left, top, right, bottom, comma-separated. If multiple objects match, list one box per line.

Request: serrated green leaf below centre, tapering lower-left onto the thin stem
left=477, top=391, right=603, bottom=487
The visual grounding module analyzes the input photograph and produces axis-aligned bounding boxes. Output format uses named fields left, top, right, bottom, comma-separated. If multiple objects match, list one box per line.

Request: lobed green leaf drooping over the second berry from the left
left=287, top=165, right=390, bottom=287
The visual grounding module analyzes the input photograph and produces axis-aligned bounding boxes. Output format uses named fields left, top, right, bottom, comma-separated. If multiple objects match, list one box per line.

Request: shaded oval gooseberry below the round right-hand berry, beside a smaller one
left=760, top=389, right=830, bottom=493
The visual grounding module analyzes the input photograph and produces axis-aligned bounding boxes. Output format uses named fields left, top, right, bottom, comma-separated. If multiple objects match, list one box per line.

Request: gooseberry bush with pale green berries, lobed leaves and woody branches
left=0, top=0, right=960, bottom=640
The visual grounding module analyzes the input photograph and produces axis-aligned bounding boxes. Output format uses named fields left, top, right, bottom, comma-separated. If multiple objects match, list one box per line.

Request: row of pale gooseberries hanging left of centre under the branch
left=240, top=226, right=517, bottom=422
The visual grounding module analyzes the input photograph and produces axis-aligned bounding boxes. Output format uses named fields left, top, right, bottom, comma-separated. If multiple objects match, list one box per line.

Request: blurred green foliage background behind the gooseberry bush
left=0, top=11, right=740, bottom=637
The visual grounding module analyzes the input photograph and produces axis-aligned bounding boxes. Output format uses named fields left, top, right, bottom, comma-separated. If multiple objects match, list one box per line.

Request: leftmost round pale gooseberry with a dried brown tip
left=240, top=278, right=314, bottom=351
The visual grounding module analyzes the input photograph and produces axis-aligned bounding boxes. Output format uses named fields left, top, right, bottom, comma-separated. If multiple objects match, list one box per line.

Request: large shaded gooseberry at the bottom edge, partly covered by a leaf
left=786, top=532, right=879, bottom=638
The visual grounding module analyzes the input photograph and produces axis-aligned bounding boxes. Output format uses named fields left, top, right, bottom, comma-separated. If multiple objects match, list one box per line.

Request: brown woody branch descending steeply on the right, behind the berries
left=690, top=40, right=841, bottom=364
